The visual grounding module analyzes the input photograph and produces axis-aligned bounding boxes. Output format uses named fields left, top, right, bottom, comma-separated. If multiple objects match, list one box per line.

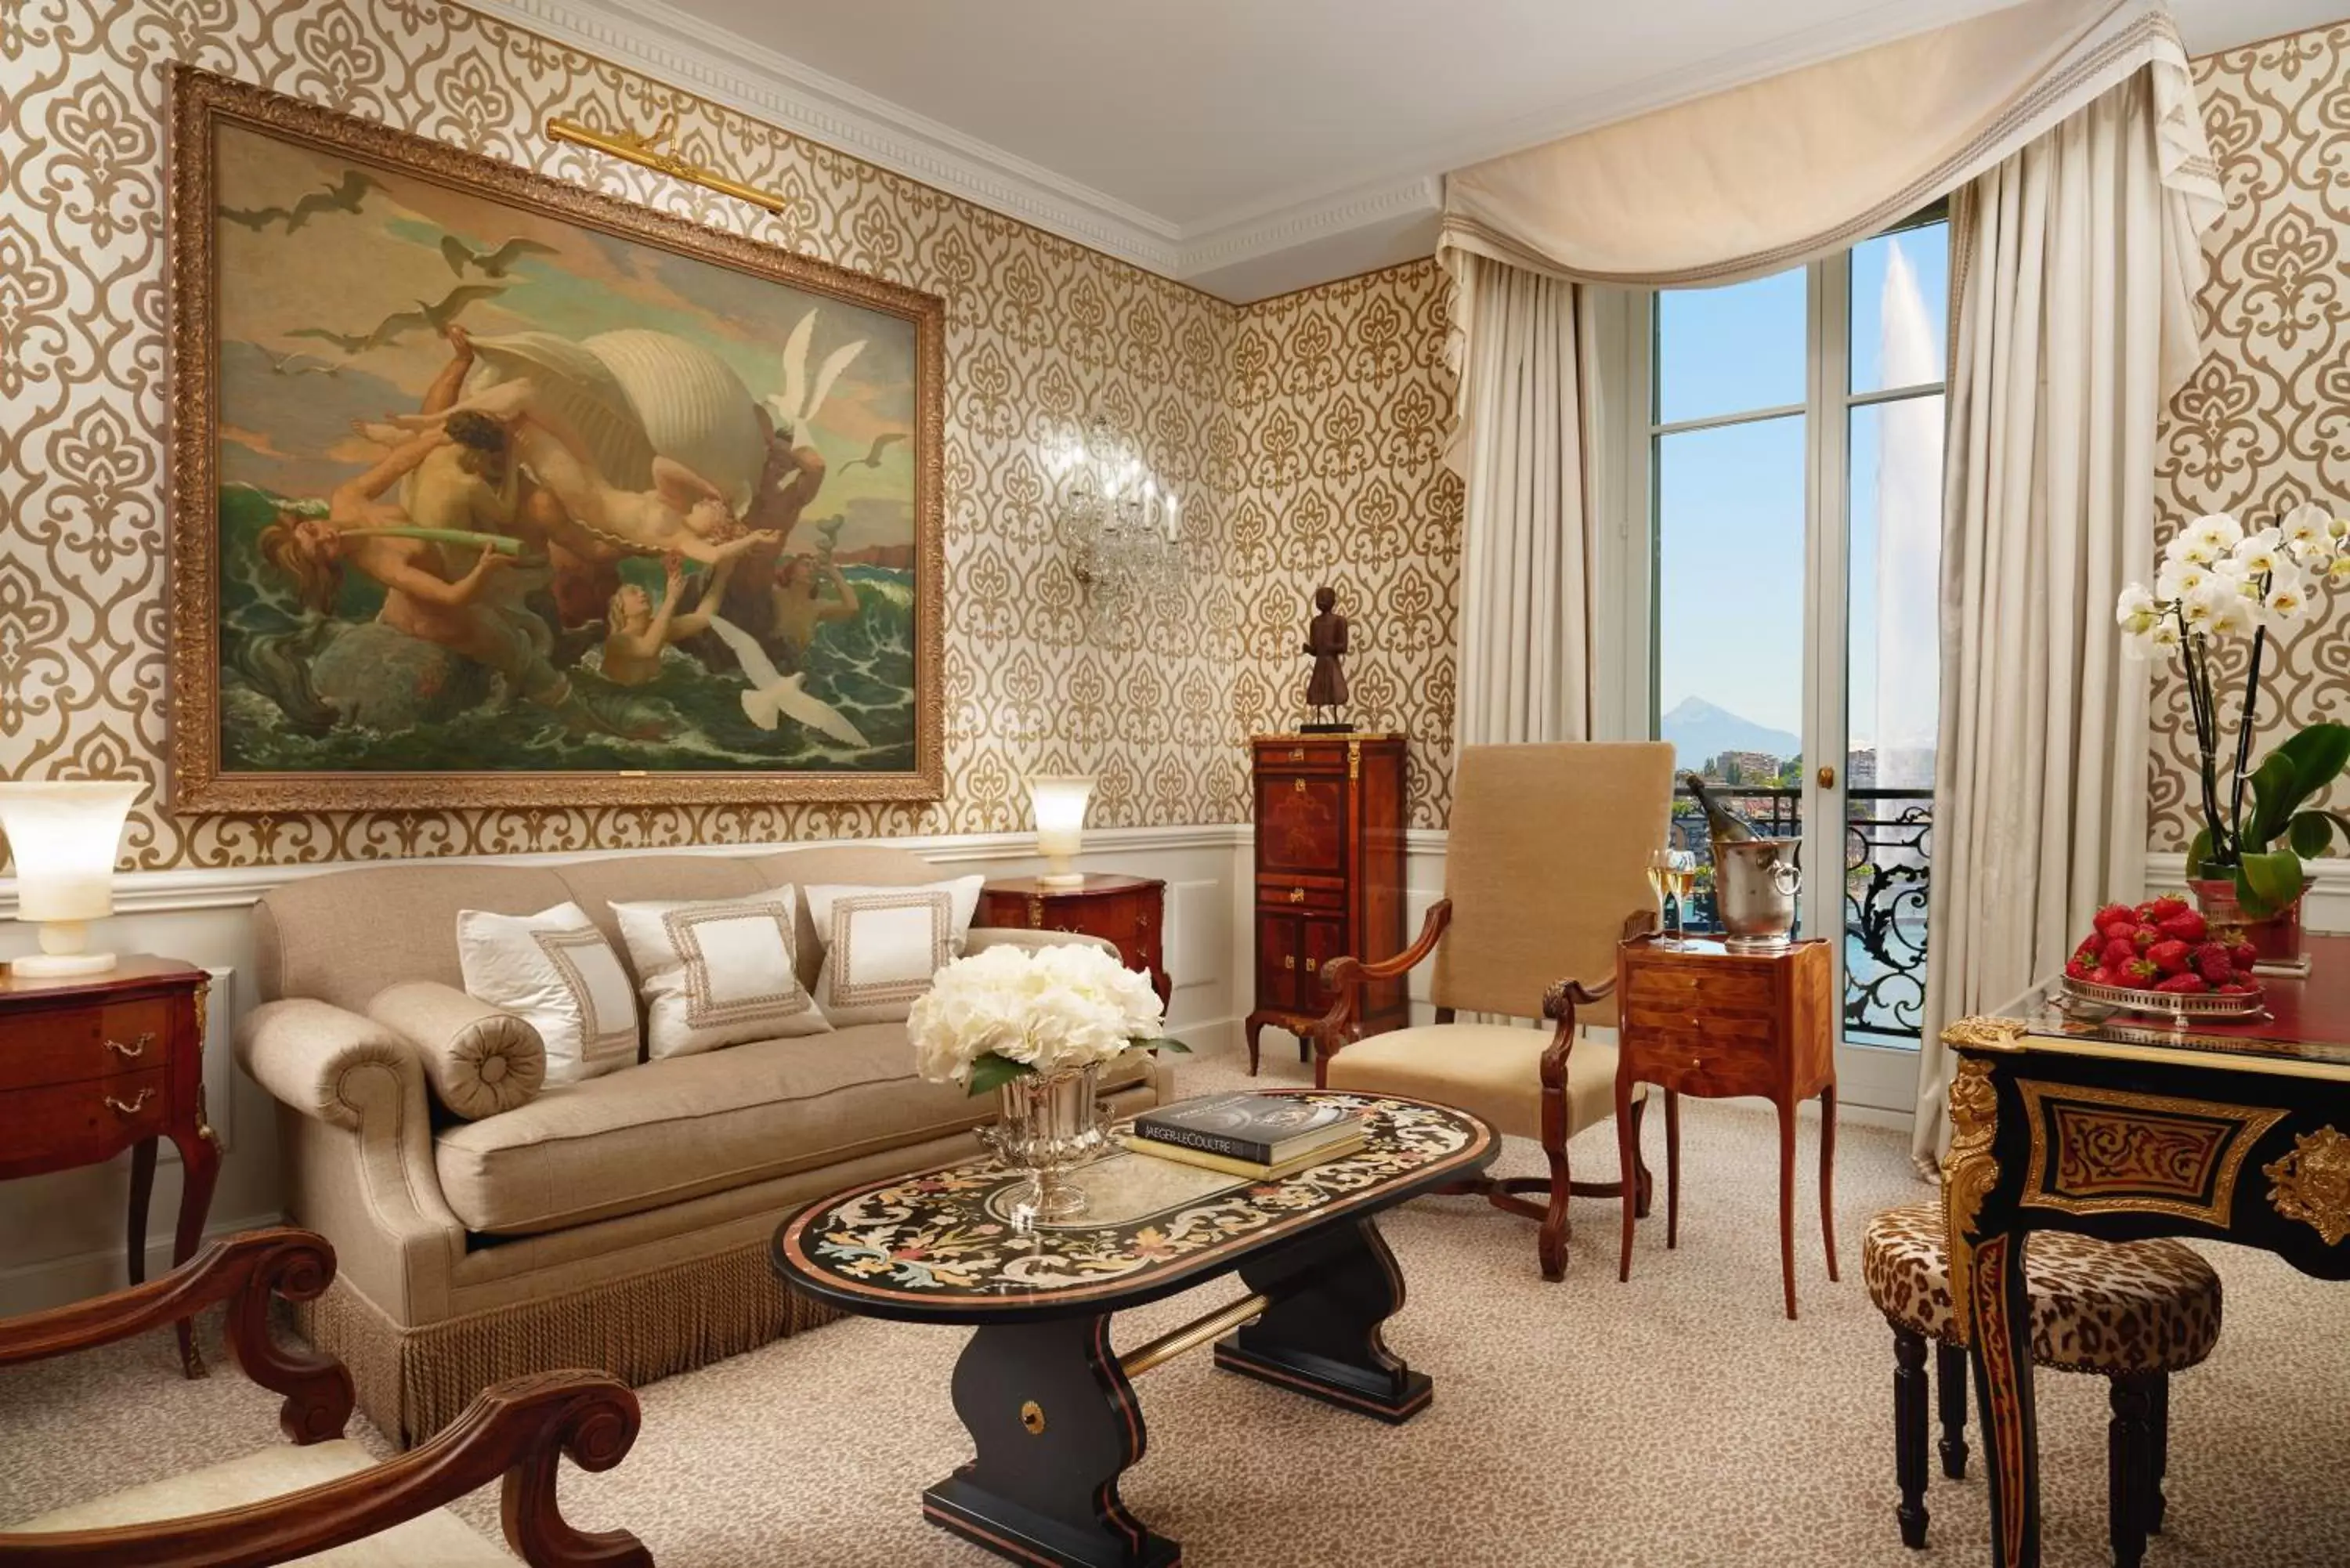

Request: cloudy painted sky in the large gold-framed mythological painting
left=214, top=127, right=914, bottom=547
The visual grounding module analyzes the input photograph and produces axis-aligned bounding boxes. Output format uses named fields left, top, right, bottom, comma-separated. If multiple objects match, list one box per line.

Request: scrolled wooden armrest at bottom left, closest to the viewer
left=0, top=1371, right=653, bottom=1568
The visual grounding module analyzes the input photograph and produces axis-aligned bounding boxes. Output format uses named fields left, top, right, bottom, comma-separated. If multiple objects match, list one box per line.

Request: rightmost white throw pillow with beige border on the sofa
left=806, top=877, right=987, bottom=1025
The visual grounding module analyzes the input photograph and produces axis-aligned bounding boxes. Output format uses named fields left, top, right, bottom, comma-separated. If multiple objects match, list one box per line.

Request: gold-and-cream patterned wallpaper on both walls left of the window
left=0, top=0, right=1459, bottom=870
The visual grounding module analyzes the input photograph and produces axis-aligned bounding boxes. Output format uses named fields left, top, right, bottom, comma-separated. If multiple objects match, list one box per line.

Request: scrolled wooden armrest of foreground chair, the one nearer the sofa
left=0, top=1225, right=350, bottom=1443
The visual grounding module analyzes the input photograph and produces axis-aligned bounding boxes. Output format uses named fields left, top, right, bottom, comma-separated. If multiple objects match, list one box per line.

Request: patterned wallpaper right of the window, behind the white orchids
left=2148, top=21, right=2350, bottom=851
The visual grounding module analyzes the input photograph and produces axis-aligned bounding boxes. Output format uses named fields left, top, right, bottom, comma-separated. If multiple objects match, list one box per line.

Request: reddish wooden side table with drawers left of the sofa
left=0, top=955, right=221, bottom=1378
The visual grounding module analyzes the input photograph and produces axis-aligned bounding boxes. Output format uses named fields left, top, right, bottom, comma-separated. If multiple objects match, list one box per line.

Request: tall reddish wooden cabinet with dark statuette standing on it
left=1248, top=733, right=1405, bottom=1072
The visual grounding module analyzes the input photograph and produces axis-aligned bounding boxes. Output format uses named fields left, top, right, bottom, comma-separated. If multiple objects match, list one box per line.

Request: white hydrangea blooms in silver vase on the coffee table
left=907, top=943, right=1189, bottom=1093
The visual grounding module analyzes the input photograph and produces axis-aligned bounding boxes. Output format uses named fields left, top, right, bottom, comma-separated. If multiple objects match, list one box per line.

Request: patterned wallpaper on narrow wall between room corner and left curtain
left=1222, top=261, right=1462, bottom=828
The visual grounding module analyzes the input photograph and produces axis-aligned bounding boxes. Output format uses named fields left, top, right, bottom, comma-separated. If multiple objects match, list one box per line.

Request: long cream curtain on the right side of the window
left=1913, top=75, right=2221, bottom=1171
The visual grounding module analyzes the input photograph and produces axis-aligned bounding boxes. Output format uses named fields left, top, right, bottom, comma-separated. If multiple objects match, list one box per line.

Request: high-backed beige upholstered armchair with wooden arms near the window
left=1314, top=742, right=1673, bottom=1279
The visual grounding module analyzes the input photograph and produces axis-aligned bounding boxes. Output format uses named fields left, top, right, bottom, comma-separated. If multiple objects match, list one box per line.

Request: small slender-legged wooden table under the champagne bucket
left=1617, top=936, right=1835, bottom=1317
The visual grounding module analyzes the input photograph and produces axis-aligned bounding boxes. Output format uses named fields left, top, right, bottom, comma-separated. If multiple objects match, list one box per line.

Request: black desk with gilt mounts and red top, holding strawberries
left=1943, top=936, right=2350, bottom=1568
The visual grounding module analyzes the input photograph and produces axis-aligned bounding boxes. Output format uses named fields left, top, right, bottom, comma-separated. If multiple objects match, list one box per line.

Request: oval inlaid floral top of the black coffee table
left=776, top=1091, right=1497, bottom=1324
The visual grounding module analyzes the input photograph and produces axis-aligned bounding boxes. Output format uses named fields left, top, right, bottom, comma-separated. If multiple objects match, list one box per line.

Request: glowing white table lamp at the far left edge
left=0, top=780, right=146, bottom=978
